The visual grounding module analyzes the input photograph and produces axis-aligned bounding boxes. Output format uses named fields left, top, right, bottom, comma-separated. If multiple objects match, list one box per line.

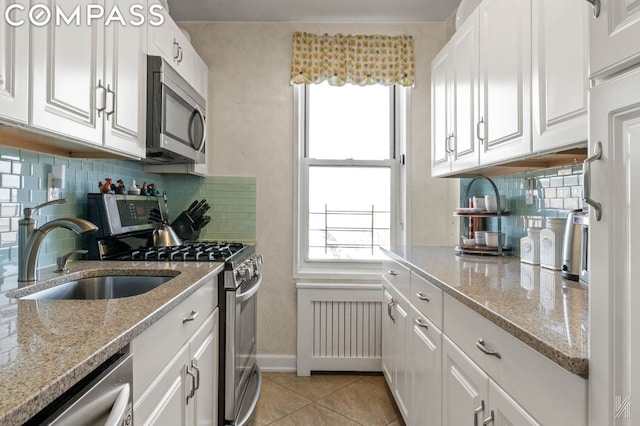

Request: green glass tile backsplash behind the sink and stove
left=0, top=146, right=256, bottom=277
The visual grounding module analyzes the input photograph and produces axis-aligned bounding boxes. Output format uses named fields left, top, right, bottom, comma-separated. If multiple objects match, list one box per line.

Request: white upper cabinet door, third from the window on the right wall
left=479, top=0, right=531, bottom=165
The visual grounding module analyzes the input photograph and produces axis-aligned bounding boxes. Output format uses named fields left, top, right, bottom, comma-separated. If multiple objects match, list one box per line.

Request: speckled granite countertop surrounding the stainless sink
left=0, top=261, right=224, bottom=425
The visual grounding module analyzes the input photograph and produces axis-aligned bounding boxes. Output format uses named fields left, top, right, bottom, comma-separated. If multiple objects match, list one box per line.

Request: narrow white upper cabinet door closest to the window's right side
left=431, top=46, right=452, bottom=176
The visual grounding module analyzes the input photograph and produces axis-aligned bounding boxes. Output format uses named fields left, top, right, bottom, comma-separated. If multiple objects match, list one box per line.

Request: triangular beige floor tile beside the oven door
left=252, top=376, right=311, bottom=426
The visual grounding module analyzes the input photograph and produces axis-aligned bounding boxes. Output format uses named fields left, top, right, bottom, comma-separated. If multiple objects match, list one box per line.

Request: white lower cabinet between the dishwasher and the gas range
left=131, top=281, right=219, bottom=426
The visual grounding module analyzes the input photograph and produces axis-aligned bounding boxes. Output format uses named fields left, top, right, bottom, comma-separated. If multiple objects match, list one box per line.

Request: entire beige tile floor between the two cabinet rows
left=252, top=373, right=404, bottom=426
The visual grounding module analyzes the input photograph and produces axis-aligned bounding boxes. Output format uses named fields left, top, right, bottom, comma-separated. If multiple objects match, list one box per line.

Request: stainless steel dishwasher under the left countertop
left=26, top=346, right=133, bottom=426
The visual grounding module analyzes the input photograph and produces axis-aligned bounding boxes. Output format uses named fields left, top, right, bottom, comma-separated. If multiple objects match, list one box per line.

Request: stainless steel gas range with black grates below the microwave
left=87, top=194, right=262, bottom=426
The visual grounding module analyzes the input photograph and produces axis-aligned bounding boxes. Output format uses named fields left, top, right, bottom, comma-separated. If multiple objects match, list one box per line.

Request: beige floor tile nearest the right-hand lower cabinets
left=318, top=380, right=400, bottom=426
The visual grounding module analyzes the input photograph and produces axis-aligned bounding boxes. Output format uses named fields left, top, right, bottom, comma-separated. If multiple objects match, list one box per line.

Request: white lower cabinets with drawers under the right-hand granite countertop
left=382, top=261, right=588, bottom=426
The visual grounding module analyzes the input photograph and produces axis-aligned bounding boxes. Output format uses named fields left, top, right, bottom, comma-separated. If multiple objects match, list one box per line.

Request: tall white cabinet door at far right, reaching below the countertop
left=585, top=67, right=640, bottom=425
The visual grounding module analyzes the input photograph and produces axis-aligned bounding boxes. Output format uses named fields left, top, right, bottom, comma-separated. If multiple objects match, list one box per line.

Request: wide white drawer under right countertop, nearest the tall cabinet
left=444, top=294, right=587, bottom=425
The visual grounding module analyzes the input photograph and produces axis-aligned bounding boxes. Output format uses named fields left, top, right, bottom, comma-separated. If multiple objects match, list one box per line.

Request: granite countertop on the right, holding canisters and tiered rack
left=382, top=246, right=589, bottom=377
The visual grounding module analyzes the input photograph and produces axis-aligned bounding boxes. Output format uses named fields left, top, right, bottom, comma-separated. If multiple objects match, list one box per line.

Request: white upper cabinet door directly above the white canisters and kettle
left=532, top=0, right=589, bottom=152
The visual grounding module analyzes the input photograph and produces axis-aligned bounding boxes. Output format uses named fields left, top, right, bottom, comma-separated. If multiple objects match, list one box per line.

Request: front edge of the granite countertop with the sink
left=0, top=263, right=224, bottom=425
